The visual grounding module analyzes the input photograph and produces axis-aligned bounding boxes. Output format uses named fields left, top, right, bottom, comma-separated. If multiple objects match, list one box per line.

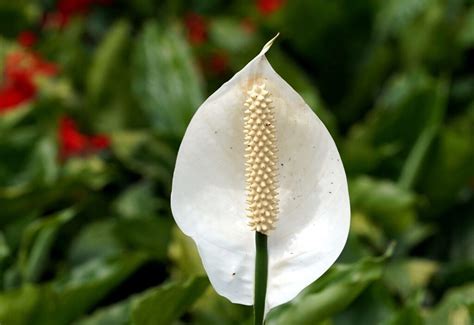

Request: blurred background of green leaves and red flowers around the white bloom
left=0, top=0, right=474, bottom=325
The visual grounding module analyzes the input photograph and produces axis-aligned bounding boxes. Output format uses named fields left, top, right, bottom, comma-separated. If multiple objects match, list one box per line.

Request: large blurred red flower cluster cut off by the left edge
left=0, top=51, right=58, bottom=113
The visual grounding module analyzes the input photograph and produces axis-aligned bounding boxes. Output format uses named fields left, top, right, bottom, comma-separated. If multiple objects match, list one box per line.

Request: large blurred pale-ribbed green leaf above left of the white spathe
left=132, top=22, right=203, bottom=136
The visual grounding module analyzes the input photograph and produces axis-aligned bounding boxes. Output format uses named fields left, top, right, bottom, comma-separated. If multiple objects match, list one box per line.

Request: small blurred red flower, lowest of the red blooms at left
left=59, top=117, right=110, bottom=159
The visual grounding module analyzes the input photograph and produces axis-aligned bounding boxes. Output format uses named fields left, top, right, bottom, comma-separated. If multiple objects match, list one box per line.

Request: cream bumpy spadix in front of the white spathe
left=244, top=83, right=278, bottom=234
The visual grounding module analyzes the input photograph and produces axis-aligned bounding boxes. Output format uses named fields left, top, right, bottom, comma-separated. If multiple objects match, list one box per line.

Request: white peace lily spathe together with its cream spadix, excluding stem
left=171, top=36, right=350, bottom=310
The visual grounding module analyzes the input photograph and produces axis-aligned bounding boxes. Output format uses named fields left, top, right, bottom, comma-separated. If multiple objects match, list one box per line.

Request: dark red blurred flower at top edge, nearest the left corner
left=43, top=0, right=112, bottom=28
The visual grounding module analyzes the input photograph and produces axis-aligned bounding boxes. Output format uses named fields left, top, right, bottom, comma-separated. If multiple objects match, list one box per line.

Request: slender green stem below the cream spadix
left=253, top=231, right=268, bottom=325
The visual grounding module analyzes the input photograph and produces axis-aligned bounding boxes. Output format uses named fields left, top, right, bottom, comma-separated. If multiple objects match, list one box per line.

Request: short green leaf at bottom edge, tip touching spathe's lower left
left=132, top=277, right=208, bottom=325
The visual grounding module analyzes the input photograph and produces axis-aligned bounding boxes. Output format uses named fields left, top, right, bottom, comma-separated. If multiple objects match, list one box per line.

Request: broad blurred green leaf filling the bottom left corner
left=0, top=254, right=145, bottom=325
